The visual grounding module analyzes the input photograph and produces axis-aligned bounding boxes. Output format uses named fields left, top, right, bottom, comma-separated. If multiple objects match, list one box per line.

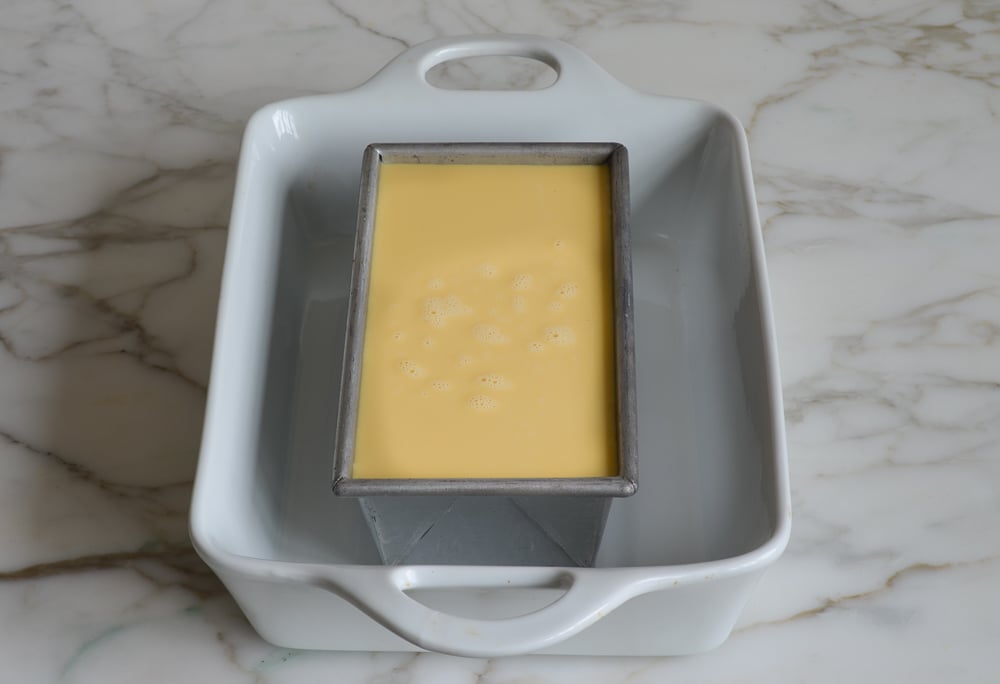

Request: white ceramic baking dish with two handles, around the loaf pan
left=191, top=36, right=789, bottom=656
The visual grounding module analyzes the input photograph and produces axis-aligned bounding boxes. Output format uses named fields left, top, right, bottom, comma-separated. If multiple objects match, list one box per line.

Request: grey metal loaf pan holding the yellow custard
left=333, top=143, right=637, bottom=566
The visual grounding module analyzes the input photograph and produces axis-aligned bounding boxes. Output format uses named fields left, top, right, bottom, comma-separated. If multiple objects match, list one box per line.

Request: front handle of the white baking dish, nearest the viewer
left=306, top=566, right=662, bottom=658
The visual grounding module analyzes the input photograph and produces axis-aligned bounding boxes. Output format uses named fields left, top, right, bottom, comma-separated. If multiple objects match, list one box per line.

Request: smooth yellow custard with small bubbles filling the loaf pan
left=352, top=163, right=618, bottom=478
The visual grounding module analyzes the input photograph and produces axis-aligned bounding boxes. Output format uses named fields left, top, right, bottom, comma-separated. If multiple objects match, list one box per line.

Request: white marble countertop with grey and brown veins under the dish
left=0, top=0, right=1000, bottom=684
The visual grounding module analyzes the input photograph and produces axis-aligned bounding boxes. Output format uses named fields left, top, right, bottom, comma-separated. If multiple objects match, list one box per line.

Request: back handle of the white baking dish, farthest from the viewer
left=362, top=35, right=627, bottom=99
